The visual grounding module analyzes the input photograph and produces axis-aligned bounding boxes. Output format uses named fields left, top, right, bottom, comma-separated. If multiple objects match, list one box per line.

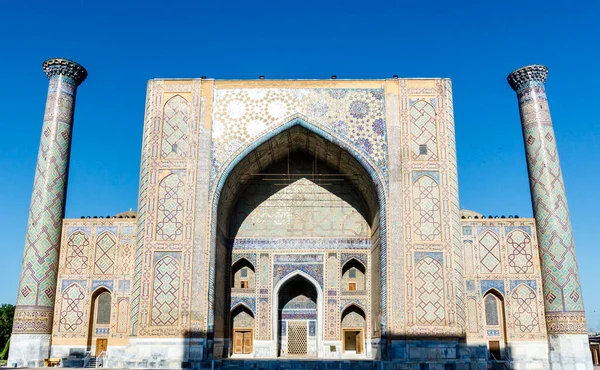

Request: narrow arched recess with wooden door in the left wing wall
left=87, top=287, right=112, bottom=354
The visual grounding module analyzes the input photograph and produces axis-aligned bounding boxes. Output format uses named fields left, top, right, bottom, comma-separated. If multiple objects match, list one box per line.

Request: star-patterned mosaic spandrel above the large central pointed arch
left=212, top=89, right=387, bottom=182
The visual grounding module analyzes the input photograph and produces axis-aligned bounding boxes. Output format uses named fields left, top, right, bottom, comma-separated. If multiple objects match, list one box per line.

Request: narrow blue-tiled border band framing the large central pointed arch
left=206, top=114, right=388, bottom=342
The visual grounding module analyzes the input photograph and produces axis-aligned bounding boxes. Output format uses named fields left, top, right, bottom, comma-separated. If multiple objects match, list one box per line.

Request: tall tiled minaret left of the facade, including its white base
left=8, top=58, right=87, bottom=366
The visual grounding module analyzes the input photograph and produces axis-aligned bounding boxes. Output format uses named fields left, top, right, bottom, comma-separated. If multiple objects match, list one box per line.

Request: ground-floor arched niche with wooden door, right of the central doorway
left=340, top=304, right=367, bottom=355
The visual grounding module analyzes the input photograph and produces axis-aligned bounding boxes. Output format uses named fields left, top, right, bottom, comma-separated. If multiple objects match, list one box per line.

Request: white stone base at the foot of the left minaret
left=6, top=334, right=52, bottom=367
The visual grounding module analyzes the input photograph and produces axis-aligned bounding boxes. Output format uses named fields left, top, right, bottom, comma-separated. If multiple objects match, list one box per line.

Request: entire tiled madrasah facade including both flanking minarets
left=8, top=58, right=592, bottom=370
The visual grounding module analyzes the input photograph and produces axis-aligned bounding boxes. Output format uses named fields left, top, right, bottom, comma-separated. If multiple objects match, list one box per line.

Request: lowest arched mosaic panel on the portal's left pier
left=152, top=255, right=181, bottom=326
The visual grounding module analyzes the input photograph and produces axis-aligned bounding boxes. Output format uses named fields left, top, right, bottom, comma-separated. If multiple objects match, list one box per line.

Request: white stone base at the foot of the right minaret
left=548, top=334, right=593, bottom=370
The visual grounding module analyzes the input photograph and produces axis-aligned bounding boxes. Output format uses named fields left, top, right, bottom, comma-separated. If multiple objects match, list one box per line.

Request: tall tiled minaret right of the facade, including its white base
left=508, top=65, right=592, bottom=370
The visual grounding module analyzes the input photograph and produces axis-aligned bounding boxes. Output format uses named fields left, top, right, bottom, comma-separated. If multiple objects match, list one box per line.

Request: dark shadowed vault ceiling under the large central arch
left=218, top=125, right=379, bottom=238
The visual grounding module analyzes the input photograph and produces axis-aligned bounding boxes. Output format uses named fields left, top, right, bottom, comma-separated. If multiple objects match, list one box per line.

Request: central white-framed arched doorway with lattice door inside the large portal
left=274, top=273, right=322, bottom=357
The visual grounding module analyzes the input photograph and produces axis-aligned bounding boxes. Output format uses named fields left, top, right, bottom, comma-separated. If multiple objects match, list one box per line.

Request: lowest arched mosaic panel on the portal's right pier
left=415, top=257, right=446, bottom=325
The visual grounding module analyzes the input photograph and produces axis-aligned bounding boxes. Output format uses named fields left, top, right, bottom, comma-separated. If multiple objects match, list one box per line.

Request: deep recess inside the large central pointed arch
left=214, top=124, right=382, bottom=357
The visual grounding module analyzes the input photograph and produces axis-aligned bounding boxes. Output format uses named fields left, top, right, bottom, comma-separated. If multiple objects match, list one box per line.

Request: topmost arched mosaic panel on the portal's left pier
left=160, top=95, right=191, bottom=158
